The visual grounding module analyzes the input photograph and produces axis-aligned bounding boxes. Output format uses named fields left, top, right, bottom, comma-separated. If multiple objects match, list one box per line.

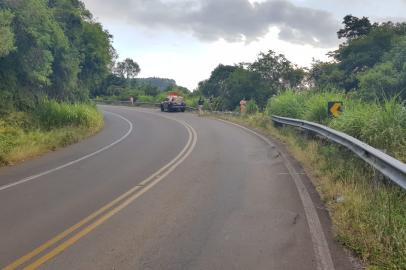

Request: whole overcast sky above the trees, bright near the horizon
left=83, top=0, right=406, bottom=89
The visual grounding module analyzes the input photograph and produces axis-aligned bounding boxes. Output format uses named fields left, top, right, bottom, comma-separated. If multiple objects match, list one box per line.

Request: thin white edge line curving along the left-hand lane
left=0, top=111, right=133, bottom=191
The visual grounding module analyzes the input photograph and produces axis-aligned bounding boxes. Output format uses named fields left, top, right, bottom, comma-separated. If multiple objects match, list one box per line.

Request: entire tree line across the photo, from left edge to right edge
left=0, top=0, right=406, bottom=114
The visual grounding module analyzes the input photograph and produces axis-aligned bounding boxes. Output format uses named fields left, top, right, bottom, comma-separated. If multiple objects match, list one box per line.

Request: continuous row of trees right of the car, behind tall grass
left=198, top=15, right=406, bottom=110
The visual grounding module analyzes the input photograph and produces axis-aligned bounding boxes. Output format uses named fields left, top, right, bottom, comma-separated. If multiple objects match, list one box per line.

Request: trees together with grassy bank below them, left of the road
left=0, top=0, right=115, bottom=166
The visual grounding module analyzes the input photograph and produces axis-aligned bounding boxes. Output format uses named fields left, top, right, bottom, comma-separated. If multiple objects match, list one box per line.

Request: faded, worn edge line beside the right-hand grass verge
left=217, top=118, right=334, bottom=270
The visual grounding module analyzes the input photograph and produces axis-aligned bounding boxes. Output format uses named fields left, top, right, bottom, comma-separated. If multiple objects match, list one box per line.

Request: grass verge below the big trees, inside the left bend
left=0, top=100, right=103, bottom=166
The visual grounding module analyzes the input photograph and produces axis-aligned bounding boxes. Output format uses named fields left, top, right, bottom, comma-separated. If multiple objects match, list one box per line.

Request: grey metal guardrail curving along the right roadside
left=271, top=115, right=406, bottom=190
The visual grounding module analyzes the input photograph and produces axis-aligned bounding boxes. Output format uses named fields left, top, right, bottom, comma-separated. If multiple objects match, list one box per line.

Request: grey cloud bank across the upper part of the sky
left=85, top=0, right=339, bottom=47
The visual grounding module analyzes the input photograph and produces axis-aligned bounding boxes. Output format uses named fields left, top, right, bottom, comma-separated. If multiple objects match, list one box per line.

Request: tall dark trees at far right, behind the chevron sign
left=309, top=15, right=406, bottom=100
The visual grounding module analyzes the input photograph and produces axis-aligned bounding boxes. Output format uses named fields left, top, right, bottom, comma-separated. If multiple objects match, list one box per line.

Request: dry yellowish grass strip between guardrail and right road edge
left=216, top=114, right=406, bottom=270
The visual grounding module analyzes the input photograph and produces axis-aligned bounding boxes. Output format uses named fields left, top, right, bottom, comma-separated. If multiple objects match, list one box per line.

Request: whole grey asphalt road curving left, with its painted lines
left=0, top=106, right=353, bottom=270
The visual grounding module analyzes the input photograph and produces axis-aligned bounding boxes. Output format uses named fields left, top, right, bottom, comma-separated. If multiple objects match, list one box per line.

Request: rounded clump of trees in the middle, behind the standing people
left=198, top=51, right=305, bottom=110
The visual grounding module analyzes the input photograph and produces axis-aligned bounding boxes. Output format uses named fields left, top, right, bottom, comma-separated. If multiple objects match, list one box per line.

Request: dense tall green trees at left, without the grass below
left=0, top=0, right=115, bottom=114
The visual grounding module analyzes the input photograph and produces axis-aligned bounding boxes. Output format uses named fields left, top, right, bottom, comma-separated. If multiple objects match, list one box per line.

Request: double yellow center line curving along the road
left=4, top=119, right=197, bottom=270
